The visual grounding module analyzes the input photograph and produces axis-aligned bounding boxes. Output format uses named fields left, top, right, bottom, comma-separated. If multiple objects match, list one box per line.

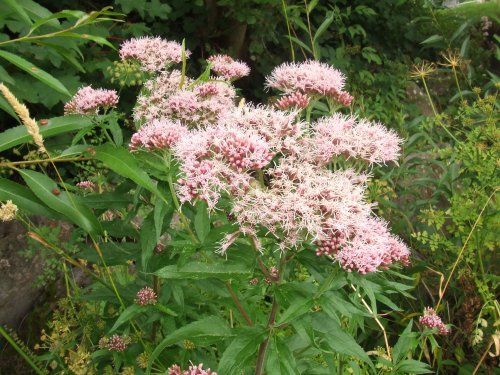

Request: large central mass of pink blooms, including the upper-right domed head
left=126, top=52, right=410, bottom=274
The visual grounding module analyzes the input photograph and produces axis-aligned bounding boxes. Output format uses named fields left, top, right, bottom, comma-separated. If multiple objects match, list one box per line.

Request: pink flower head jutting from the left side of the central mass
left=129, top=119, right=189, bottom=150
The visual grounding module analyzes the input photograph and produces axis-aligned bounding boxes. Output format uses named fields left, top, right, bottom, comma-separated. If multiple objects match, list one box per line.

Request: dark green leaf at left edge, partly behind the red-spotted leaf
left=0, top=178, right=61, bottom=219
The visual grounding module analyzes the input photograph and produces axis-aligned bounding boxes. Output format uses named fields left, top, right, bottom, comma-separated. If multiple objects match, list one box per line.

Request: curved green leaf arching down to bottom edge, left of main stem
left=146, top=316, right=232, bottom=374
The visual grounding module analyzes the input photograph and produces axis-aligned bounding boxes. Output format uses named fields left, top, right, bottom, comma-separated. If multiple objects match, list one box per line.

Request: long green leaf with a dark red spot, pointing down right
left=19, top=169, right=102, bottom=236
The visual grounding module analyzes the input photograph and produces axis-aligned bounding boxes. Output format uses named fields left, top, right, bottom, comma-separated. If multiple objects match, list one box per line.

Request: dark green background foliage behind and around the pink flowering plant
left=0, top=0, right=500, bottom=374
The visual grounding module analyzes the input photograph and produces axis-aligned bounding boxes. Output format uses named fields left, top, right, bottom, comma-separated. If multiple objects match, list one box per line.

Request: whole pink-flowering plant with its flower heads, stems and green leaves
left=1, top=37, right=442, bottom=375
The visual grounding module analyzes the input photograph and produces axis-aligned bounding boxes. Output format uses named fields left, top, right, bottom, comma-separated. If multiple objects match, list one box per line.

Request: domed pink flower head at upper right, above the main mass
left=267, top=60, right=352, bottom=105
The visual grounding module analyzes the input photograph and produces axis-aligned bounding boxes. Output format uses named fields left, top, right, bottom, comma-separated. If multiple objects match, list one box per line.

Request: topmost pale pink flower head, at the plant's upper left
left=120, top=36, right=191, bottom=72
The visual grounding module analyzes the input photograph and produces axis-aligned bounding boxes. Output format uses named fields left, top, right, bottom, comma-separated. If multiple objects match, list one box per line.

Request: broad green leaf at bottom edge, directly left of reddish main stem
left=217, top=326, right=267, bottom=374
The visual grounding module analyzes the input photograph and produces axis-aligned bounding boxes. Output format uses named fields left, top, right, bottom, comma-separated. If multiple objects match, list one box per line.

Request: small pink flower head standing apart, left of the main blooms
left=64, top=86, right=118, bottom=115
